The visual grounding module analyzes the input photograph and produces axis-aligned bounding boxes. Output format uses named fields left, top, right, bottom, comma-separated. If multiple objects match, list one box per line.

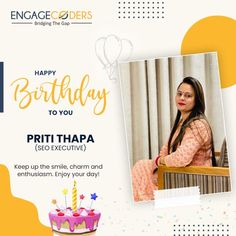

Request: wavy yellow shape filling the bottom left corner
left=0, top=165, right=52, bottom=236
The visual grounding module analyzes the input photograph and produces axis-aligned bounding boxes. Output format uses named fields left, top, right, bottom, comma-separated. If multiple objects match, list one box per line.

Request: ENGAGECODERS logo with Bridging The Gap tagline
left=10, top=10, right=93, bottom=26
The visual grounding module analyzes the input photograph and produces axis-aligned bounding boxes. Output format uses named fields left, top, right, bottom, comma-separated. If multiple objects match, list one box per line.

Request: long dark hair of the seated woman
left=168, top=77, right=216, bottom=166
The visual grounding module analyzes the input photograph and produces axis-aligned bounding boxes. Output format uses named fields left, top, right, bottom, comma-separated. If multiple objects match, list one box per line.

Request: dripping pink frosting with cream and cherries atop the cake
left=49, top=208, right=101, bottom=232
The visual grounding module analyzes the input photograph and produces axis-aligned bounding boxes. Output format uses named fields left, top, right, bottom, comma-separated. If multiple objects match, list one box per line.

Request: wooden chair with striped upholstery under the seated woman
left=158, top=139, right=231, bottom=194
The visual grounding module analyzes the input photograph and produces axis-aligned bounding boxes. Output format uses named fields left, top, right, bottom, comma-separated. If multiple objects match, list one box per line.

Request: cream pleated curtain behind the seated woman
left=119, top=53, right=225, bottom=166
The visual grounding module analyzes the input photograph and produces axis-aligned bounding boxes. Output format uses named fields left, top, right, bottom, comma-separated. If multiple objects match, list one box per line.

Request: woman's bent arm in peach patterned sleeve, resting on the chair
left=162, top=119, right=211, bottom=167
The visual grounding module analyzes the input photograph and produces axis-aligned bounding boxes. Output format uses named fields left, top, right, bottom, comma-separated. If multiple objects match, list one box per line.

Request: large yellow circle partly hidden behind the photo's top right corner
left=181, top=16, right=236, bottom=88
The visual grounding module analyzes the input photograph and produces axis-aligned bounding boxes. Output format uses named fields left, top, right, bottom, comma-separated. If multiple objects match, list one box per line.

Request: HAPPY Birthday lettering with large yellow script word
left=11, top=70, right=109, bottom=115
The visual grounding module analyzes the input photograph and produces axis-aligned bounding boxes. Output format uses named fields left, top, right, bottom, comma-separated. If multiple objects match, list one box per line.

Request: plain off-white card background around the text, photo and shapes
left=0, top=0, right=236, bottom=235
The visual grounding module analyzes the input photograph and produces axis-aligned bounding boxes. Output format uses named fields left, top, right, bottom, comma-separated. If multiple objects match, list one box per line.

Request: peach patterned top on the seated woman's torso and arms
left=160, top=119, right=212, bottom=167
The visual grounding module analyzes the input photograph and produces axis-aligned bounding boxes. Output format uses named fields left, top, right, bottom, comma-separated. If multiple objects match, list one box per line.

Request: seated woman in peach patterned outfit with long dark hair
left=132, top=77, right=216, bottom=201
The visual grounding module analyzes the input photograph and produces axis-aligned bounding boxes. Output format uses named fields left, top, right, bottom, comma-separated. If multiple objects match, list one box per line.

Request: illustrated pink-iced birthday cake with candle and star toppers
left=49, top=182, right=101, bottom=236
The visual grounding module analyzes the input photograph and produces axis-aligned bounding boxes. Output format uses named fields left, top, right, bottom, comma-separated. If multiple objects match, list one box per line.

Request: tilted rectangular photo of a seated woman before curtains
left=119, top=53, right=231, bottom=201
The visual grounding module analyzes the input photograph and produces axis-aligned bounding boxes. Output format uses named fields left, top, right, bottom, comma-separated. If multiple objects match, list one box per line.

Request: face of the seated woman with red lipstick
left=175, top=83, right=195, bottom=113
